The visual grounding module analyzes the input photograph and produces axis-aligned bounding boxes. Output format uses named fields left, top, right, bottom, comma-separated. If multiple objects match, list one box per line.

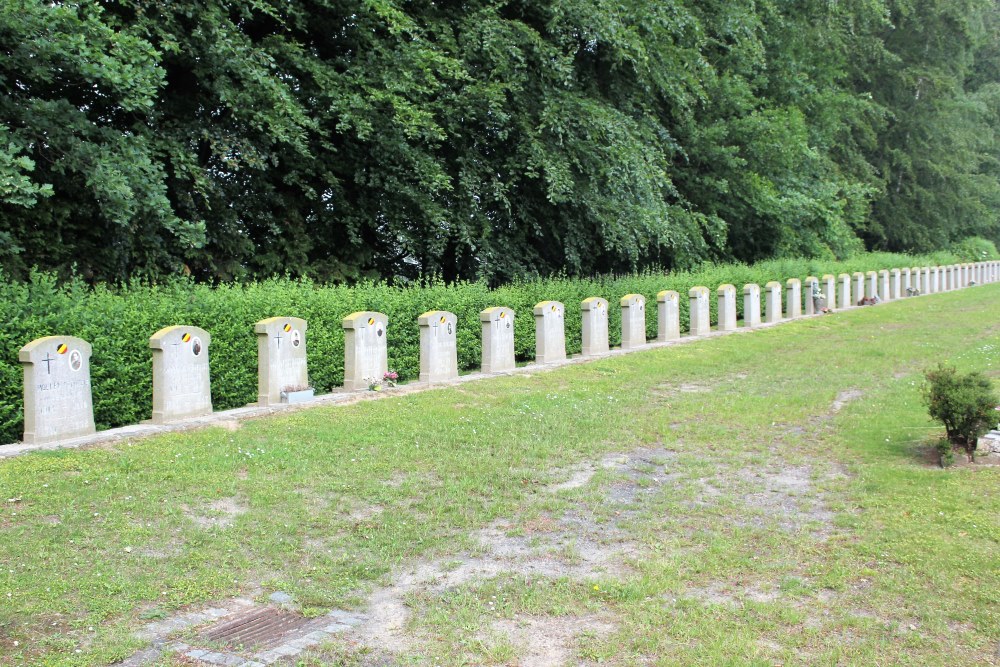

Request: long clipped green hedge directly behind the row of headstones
left=0, top=253, right=957, bottom=443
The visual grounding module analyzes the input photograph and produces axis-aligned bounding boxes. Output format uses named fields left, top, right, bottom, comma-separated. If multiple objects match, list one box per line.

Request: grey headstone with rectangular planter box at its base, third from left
left=254, top=317, right=309, bottom=408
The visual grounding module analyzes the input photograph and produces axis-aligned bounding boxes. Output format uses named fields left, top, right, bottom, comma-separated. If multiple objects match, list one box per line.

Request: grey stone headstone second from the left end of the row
left=149, top=327, right=212, bottom=424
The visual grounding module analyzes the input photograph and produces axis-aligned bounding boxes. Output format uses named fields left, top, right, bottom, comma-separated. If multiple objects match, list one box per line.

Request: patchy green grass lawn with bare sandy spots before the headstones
left=0, top=284, right=1000, bottom=666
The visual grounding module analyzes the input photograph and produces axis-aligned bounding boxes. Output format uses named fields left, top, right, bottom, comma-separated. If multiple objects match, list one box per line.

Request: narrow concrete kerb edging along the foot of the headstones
left=0, top=276, right=990, bottom=460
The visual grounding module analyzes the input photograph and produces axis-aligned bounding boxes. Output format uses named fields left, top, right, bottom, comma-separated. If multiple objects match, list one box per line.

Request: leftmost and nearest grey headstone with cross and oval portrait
left=17, top=336, right=95, bottom=445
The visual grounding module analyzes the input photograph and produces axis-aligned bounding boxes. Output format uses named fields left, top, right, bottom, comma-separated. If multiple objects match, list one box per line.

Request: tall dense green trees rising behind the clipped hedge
left=0, top=0, right=1000, bottom=285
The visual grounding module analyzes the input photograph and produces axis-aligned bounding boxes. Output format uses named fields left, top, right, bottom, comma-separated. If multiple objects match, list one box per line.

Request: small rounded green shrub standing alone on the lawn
left=924, top=364, right=997, bottom=465
